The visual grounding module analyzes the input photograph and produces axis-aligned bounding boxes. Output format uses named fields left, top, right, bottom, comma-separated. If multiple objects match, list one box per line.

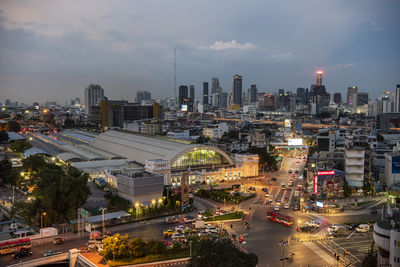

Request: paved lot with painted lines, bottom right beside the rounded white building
left=315, top=232, right=376, bottom=266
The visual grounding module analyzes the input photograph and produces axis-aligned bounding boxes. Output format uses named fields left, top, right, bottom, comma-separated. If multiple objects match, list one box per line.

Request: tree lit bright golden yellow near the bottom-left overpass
left=100, top=234, right=129, bottom=259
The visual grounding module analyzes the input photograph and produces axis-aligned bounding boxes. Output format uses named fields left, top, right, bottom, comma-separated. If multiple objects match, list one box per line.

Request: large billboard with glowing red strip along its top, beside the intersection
left=317, top=170, right=345, bottom=196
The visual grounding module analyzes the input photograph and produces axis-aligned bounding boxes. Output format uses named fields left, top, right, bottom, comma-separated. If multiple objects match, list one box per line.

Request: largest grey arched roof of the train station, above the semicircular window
left=90, top=131, right=233, bottom=165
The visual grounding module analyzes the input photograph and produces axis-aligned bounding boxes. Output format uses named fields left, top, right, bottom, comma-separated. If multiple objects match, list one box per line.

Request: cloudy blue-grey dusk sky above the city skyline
left=0, top=0, right=400, bottom=103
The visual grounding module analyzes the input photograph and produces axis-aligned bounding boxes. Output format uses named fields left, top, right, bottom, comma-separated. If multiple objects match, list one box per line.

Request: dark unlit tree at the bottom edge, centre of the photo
left=187, top=239, right=258, bottom=267
